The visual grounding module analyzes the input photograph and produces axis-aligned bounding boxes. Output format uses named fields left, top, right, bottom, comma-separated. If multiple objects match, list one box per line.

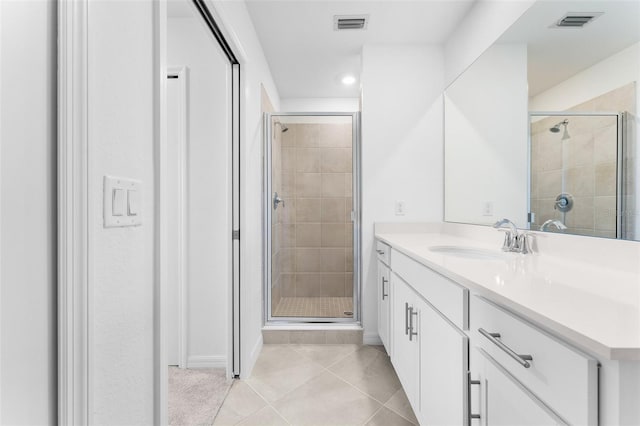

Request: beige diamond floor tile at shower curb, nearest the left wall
left=247, top=345, right=323, bottom=401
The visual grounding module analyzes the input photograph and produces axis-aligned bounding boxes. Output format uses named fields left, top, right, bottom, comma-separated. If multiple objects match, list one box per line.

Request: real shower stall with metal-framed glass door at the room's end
left=263, top=113, right=360, bottom=323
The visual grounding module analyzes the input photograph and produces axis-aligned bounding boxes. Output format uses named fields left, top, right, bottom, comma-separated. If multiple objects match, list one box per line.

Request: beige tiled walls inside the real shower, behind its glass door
left=272, top=123, right=353, bottom=303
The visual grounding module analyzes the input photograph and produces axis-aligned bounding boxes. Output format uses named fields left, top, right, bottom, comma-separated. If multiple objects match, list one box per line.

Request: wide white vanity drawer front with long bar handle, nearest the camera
left=470, top=297, right=598, bottom=425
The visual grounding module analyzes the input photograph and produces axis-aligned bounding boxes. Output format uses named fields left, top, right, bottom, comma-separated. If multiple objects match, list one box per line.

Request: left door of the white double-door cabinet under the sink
left=391, top=273, right=420, bottom=406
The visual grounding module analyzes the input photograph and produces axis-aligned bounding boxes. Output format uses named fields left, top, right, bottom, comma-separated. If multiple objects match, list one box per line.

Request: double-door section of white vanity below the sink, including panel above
left=391, top=251, right=469, bottom=425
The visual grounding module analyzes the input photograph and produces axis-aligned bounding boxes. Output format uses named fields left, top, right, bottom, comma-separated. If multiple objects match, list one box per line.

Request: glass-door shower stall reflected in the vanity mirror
left=529, top=111, right=635, bottom=238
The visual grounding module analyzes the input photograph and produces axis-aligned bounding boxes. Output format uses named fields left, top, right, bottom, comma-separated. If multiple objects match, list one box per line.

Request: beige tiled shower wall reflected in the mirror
left=531, top=83, right=636, bottom=238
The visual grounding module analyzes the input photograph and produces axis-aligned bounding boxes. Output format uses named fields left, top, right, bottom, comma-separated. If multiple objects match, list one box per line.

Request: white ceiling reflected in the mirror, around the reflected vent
left=499, top=0, right=640, bottom=96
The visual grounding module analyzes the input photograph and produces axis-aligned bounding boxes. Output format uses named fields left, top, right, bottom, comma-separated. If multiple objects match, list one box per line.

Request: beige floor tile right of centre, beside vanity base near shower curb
left=330, top=346, right=400, bottom=403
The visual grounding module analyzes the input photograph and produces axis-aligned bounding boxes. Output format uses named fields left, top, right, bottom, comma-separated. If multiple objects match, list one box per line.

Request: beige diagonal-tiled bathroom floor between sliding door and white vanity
left=214, top=345, right=418, bottom=426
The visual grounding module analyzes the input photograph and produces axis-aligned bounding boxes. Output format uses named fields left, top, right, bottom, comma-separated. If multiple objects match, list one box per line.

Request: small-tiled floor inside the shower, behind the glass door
left=273, top=297, right=353, bottom=318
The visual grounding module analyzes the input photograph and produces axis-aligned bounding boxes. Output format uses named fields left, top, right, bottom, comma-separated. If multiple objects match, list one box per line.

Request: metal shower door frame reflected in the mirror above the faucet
left=527, top=111, right=627, bottom=239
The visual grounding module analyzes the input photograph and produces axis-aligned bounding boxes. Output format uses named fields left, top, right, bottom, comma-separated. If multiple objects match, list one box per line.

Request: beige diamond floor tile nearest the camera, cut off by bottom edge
left=273, top=372, right=380, bottom=426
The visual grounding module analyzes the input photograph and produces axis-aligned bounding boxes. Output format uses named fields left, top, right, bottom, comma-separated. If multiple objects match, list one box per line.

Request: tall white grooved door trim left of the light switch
left=58, top=0, right=91, bottom=425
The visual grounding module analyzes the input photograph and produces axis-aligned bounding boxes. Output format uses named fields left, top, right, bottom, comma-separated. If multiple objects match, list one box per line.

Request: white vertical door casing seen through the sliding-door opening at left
left=166, top=66, right=189, bottom=368
